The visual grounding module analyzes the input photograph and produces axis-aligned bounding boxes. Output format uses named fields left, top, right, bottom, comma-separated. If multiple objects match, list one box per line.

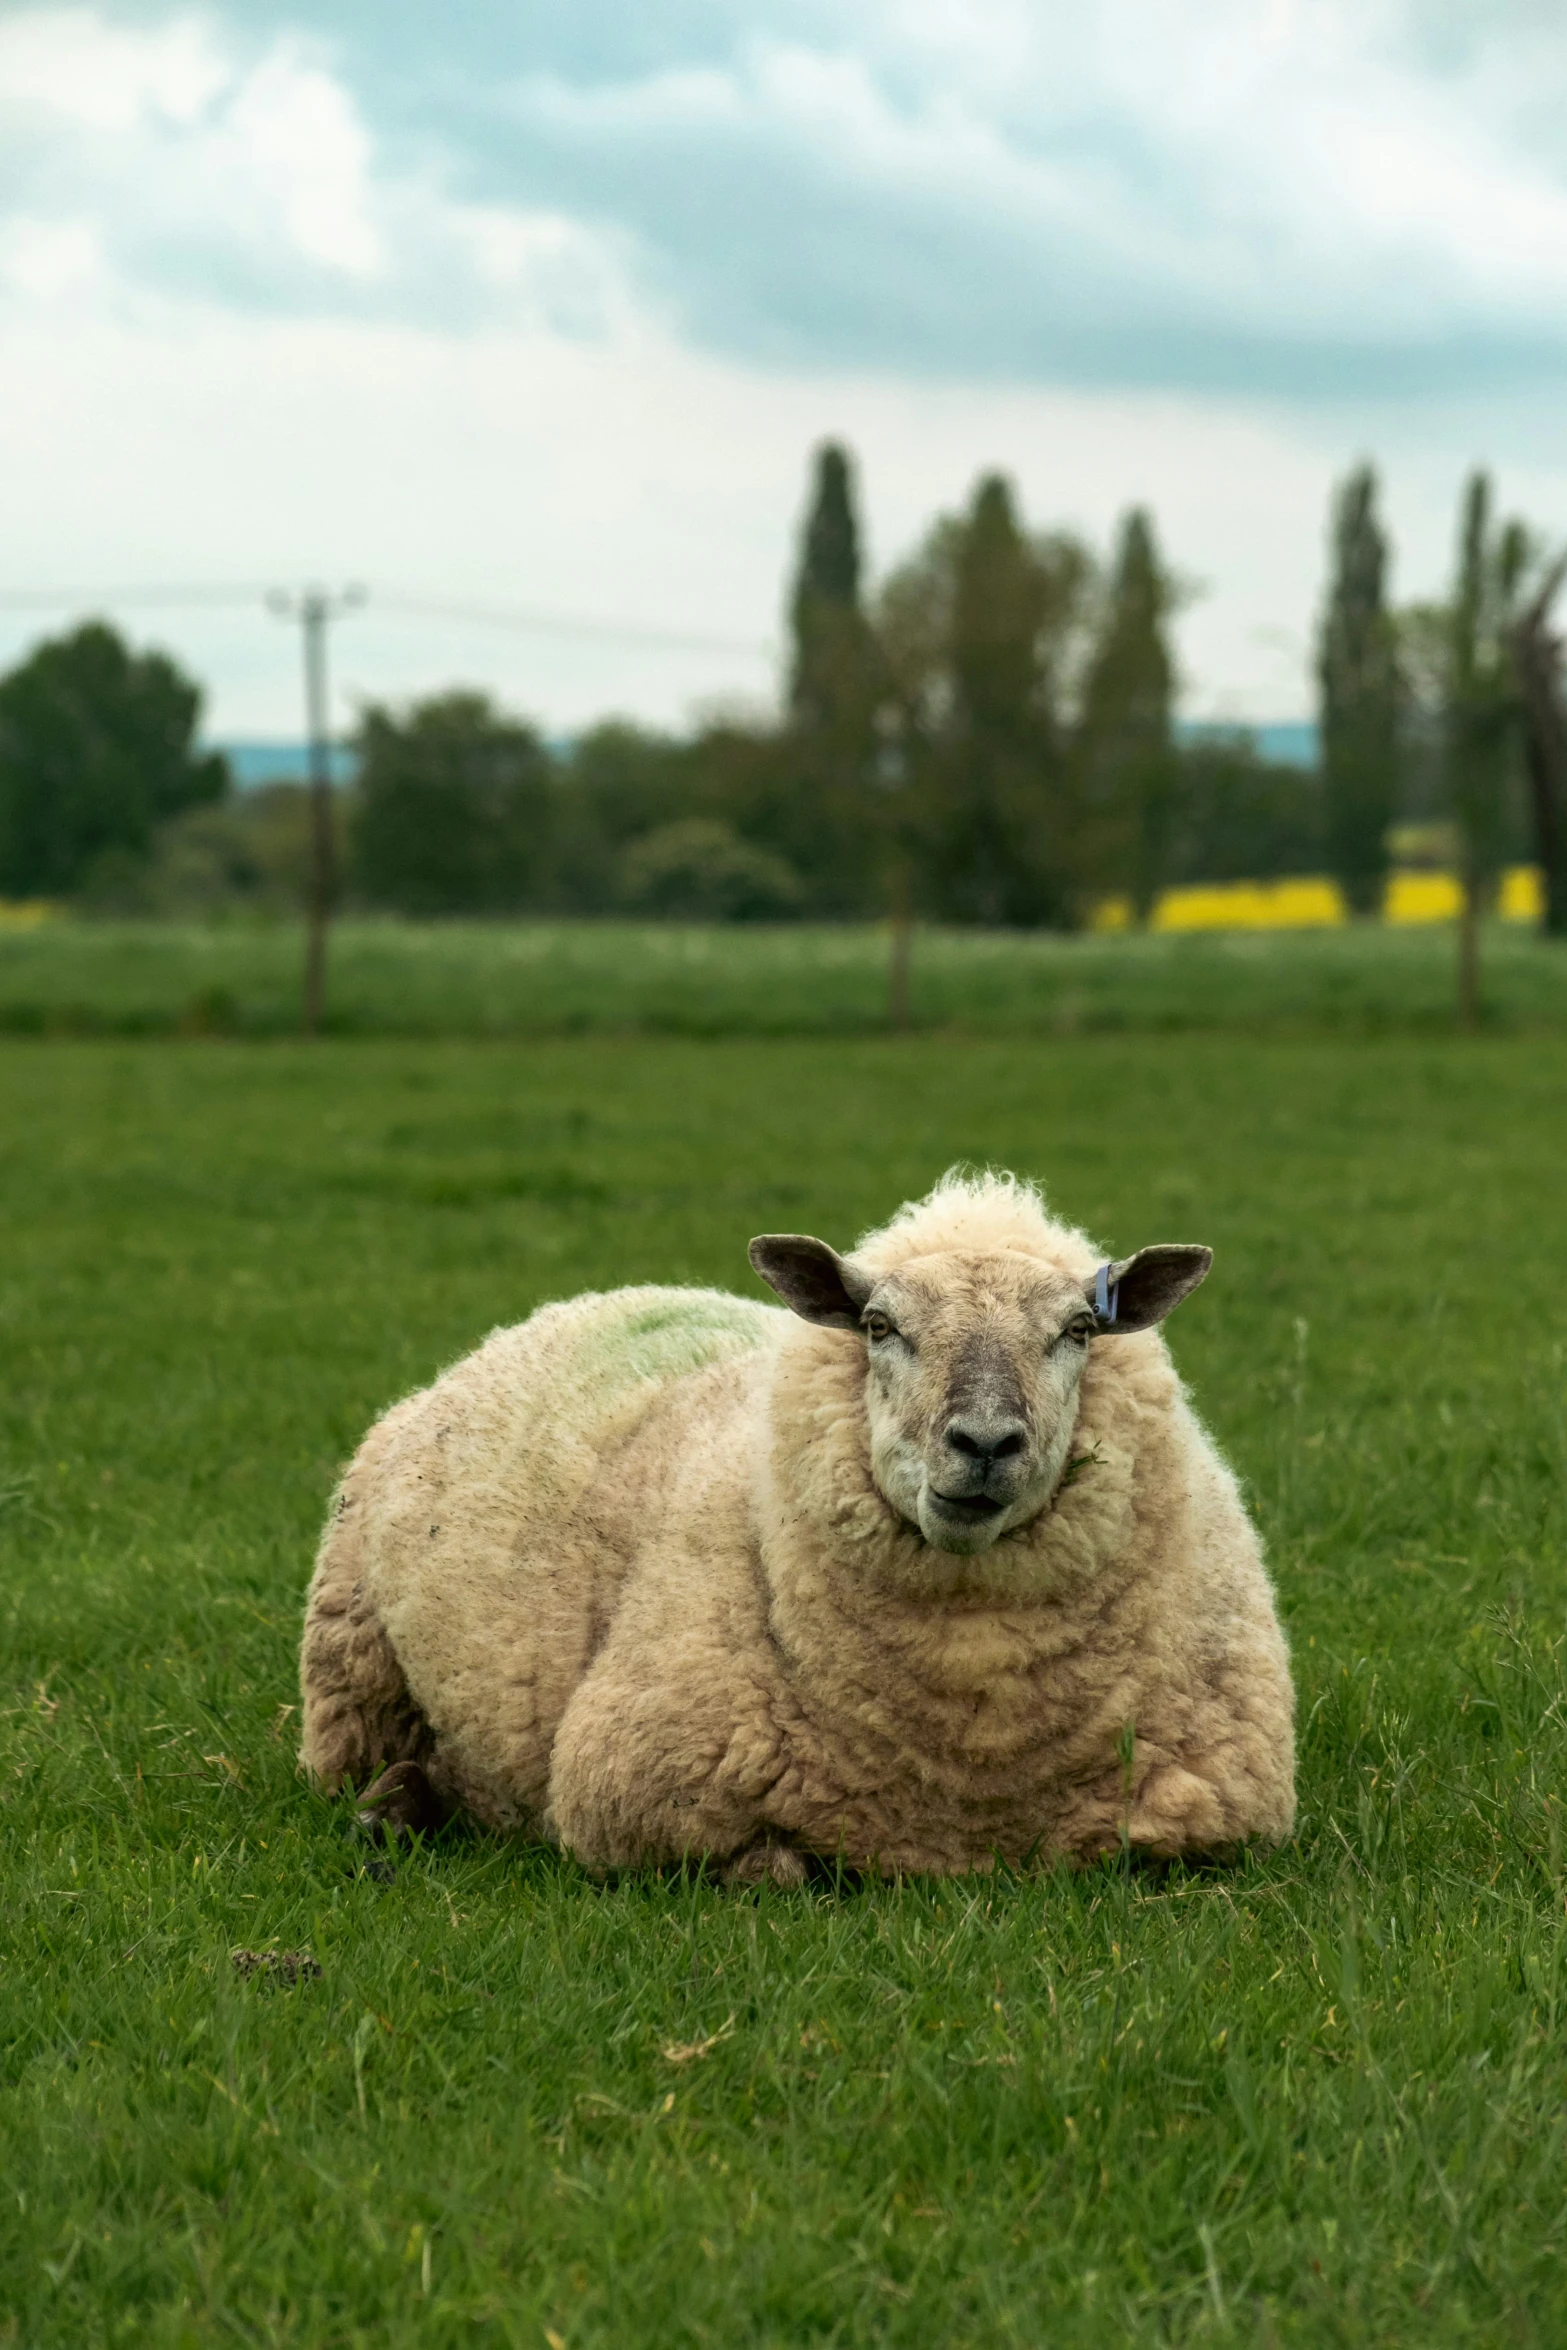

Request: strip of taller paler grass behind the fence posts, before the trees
left=0, top=921, right=1567, bottom=1039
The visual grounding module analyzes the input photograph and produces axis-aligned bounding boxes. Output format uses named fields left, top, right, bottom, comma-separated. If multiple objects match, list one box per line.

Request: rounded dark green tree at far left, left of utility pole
left=0, top=620, right=228, bottom=898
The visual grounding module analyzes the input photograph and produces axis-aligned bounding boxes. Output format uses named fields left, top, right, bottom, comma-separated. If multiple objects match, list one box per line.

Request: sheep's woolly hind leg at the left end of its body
left=298, top=1481, right=430, bottom=1805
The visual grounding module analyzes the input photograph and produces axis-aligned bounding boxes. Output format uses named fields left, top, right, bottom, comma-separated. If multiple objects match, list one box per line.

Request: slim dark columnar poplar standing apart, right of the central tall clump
left=1318, top=465, right=1400, bottom=914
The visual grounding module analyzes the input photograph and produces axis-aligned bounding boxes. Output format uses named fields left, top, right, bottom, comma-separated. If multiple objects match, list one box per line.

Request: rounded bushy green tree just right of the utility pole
left=352, top=693, right=554, bottom=914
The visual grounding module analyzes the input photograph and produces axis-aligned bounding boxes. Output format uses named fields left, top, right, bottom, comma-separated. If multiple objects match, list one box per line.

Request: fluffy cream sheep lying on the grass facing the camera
left=301, top=1173, right=1294, bottom=1885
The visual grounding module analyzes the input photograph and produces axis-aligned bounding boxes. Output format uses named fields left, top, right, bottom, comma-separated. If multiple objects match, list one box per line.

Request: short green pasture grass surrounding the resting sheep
left=0, top=1034, right=1567, bottom=2350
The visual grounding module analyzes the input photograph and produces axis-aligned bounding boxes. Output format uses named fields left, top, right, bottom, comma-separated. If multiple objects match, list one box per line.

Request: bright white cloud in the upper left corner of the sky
left=0, top=7, right=613, bottom=315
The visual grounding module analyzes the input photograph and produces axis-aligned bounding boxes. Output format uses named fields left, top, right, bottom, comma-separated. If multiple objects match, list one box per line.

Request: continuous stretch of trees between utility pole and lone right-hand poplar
left=270, top=447, right=1318, bottom=926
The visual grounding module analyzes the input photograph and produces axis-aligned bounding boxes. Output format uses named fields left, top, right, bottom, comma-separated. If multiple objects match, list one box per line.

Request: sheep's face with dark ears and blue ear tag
left=749, top=1234, right=1212, bottom=1556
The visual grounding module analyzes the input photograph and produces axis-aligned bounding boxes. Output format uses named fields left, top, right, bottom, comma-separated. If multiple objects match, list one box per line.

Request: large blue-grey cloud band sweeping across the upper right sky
left=16, top=0, right=1567, bottom=402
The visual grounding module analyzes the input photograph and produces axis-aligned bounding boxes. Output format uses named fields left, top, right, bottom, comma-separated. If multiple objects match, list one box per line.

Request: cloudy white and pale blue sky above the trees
left=0, top=0, right=1567, bottom=736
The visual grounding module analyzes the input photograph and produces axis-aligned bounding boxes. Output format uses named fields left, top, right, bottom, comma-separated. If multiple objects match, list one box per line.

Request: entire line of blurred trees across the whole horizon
left=0, top=444, right=1567, bottom=926
